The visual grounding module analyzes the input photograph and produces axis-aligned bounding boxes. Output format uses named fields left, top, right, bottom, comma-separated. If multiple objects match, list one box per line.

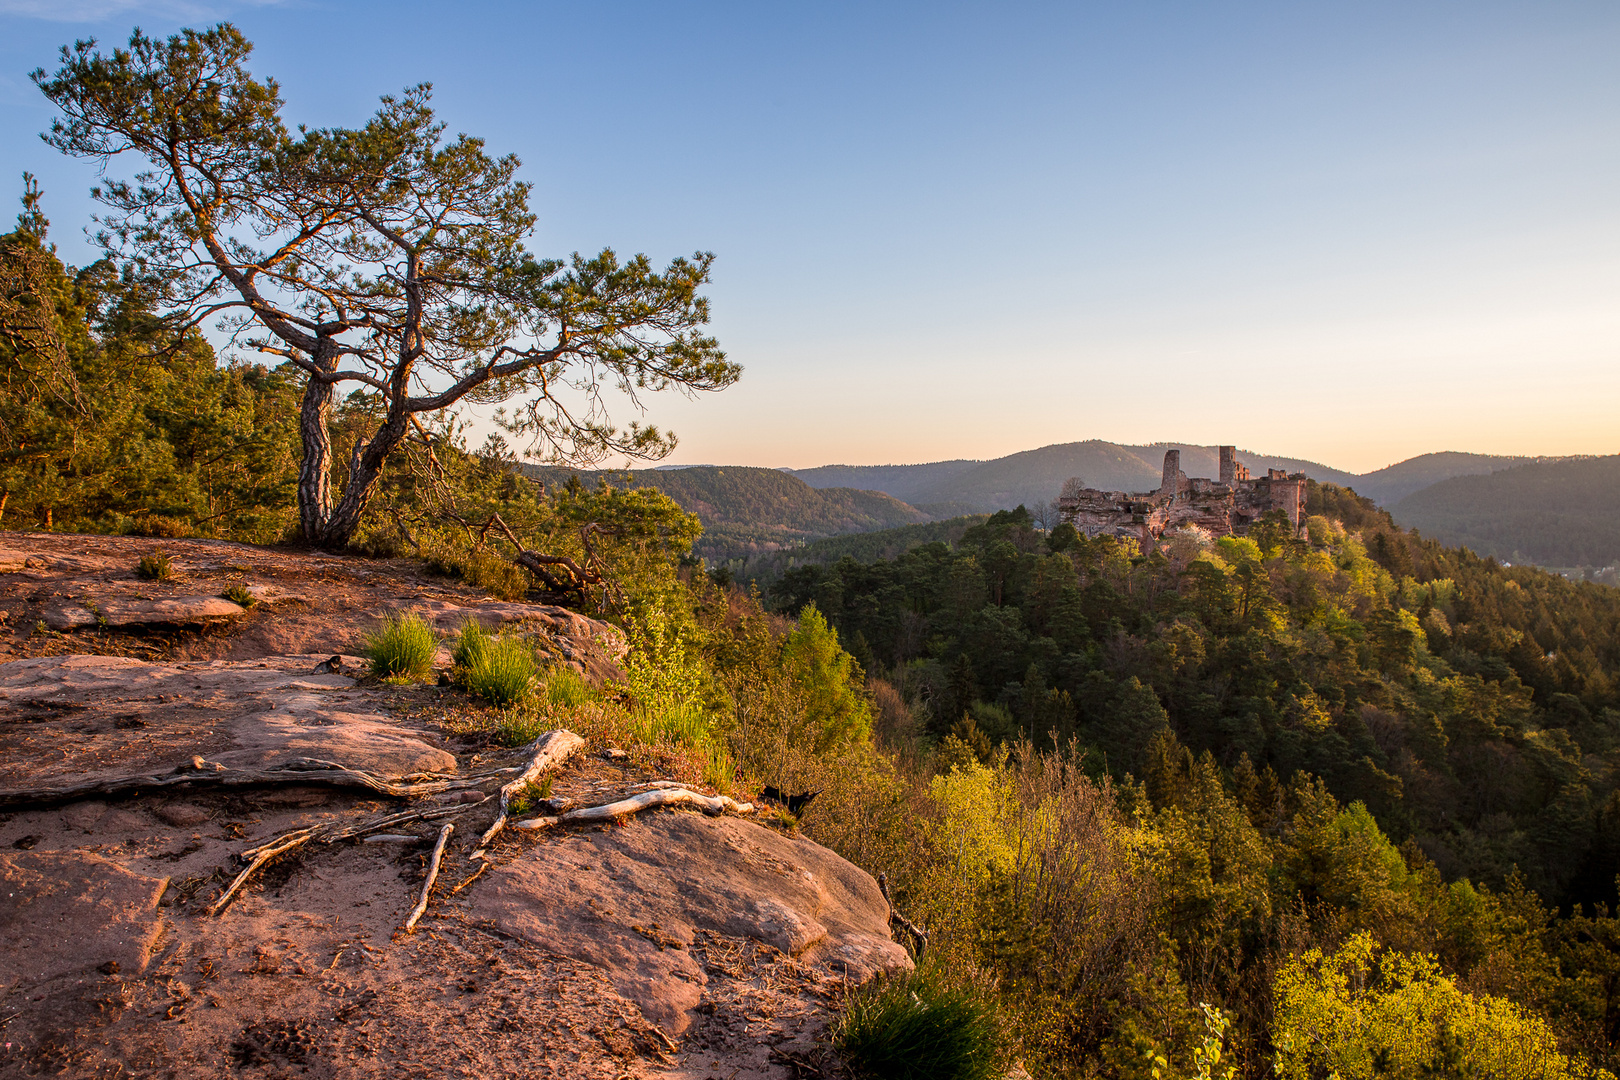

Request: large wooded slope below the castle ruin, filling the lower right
left=754, top=484, right=1620, bottom=1075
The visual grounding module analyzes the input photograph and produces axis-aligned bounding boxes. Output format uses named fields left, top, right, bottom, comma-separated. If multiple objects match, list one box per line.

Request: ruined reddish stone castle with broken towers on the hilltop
left=1058, top=447, right=1306, bottom=551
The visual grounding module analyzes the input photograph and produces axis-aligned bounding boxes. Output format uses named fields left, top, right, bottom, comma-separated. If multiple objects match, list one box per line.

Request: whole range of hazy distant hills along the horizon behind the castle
left=528, top=439, right=1620, bottom=567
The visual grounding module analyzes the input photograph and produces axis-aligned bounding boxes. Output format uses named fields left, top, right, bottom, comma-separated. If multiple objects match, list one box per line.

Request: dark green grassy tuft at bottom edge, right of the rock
left=834, top=970, right=1003, bottom=1080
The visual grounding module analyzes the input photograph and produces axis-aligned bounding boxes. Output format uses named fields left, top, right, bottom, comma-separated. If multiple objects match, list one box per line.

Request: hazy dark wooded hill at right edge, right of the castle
left=1392, top=457, right=1620, bottom=568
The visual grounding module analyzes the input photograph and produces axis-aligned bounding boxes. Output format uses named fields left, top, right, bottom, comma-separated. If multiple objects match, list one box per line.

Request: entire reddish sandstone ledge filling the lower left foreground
left=0, top=533, right=910, bottom=1080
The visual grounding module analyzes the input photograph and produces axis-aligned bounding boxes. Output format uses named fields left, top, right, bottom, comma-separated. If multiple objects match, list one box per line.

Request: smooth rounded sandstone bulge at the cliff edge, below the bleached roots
left=471, top=813, right=910, bottom=1035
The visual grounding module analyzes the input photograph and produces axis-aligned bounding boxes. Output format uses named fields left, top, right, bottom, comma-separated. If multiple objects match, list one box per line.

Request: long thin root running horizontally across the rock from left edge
left=0, top=756, right=481, bottom=810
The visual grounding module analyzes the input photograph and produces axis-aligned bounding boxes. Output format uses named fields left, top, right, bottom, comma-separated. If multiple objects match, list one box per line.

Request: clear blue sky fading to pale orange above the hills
left=0, top=0, right=1620, bottom=471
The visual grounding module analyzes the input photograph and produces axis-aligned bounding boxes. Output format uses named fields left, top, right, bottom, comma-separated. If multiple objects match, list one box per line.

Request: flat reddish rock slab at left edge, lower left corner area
left=0, top=852, right=168, bottom=989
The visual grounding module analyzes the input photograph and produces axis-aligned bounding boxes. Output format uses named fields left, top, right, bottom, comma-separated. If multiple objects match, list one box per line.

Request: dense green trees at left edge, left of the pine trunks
left=0, top=186, right=301, bottom=541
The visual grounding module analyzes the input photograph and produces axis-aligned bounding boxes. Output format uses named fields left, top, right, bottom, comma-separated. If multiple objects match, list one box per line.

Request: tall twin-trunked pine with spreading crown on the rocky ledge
left=32, top=24, right=740, bottom=549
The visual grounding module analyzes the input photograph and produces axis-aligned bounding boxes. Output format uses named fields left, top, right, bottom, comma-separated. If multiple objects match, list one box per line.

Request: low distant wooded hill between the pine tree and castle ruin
left=525, top=465, right=930, bottom=562
